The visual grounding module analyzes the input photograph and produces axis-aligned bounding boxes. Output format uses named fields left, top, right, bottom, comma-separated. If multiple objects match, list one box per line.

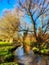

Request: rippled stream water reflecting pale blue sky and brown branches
left=15, top=46, right=49, bottom=65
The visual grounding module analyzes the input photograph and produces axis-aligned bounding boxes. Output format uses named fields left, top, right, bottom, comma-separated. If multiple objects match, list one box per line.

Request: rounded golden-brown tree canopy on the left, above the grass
left=0, top=12, right=19, bottom=42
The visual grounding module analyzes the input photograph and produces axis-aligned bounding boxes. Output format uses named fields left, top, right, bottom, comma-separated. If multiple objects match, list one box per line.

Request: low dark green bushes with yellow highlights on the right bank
left=31, top=42, right=49, bottom=54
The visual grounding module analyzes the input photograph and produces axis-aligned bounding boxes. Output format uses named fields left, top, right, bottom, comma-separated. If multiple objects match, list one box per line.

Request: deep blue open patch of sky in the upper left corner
left=0, top=0, right=16, bottom=16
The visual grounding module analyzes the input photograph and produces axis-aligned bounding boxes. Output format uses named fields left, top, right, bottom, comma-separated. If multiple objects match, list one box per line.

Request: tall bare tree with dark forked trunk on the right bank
left=16, top=0, right=49, bottom=40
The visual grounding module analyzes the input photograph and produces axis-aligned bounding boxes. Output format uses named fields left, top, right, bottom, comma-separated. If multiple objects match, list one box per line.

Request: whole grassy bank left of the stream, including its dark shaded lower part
left=0, top=42, right=16, bottom=62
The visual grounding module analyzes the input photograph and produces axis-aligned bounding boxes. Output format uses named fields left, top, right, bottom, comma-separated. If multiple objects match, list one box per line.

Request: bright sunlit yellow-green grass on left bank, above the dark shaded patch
left=0, top=42, right=13, bottom=56
